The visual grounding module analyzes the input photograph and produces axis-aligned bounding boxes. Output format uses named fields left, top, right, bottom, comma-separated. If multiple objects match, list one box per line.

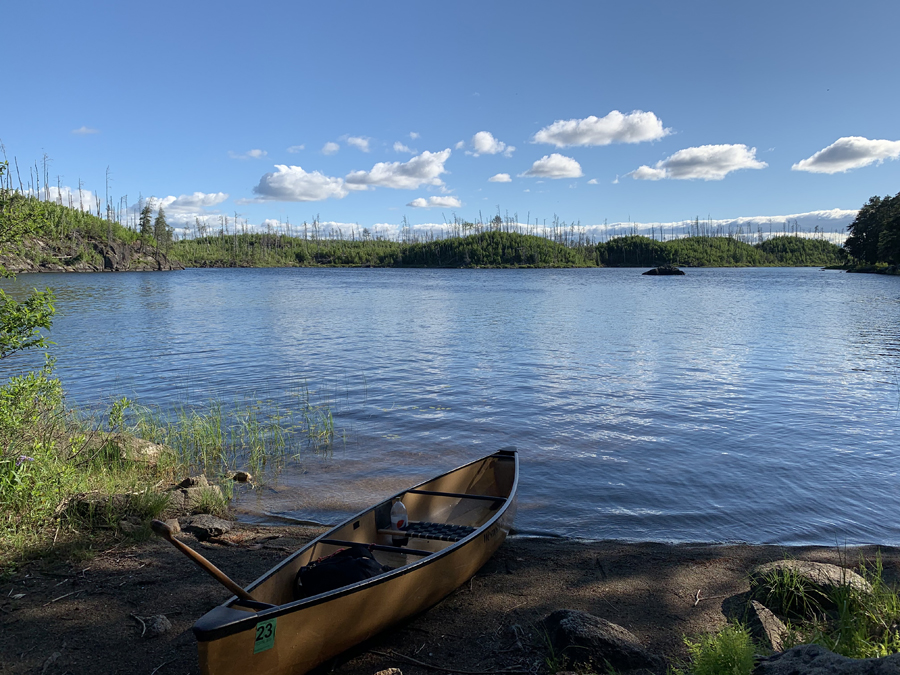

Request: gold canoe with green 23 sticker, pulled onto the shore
left=194, top=448, right=519, bottom=675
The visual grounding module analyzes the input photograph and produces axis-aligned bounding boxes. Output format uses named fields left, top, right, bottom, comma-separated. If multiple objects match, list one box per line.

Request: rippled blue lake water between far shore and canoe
left=3, top=269, right=900, bottom=545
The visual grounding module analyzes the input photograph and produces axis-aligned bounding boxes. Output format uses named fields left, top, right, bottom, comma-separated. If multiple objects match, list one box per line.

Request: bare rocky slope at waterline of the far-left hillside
left=0, top=235, right=184, bottom=274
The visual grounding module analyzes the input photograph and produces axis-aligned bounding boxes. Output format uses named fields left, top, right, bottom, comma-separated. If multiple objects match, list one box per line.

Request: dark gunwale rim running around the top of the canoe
left=193, top=447, right=519, bottom=642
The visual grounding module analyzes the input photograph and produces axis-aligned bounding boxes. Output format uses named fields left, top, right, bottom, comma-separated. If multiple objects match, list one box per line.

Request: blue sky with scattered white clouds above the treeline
left=0, top=0, right=900, bottom=240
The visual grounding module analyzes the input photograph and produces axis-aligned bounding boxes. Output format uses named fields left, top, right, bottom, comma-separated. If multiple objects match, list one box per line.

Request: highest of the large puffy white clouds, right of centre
left=531, top=110, right=671, bottom=148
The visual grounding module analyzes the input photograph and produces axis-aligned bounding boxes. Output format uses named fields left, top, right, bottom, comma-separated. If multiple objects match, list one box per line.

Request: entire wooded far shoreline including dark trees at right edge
left=0, top=162, right=900, bottom=273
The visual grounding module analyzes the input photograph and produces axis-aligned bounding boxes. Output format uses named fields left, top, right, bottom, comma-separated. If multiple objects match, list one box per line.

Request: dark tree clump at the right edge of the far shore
left=844, top=192, right=900, bottom=265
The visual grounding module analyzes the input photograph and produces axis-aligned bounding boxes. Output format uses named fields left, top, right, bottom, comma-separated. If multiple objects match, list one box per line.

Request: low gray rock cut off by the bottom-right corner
left=753, top=645, right=900, bottom=675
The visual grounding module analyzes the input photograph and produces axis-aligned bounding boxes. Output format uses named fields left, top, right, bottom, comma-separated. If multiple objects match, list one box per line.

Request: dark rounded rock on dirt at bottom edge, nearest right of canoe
left=543, top=609, right=664, bottom=671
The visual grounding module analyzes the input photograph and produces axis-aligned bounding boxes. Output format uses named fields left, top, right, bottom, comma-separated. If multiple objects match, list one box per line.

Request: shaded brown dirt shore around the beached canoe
left=0, top=526, right=900, bottom=675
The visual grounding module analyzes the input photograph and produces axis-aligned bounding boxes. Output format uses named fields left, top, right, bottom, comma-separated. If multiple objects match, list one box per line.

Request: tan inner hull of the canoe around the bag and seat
left=228, top=451, right=516, bottom=611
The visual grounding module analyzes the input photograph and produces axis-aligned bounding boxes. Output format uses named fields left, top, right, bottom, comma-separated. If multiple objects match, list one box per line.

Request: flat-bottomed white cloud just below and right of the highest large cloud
left=631, top=144, right=768, bottom=180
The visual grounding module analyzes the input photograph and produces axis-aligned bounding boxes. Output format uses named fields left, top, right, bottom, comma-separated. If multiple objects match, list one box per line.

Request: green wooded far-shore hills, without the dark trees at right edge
left=0, top=187, right=849, bottom=273
